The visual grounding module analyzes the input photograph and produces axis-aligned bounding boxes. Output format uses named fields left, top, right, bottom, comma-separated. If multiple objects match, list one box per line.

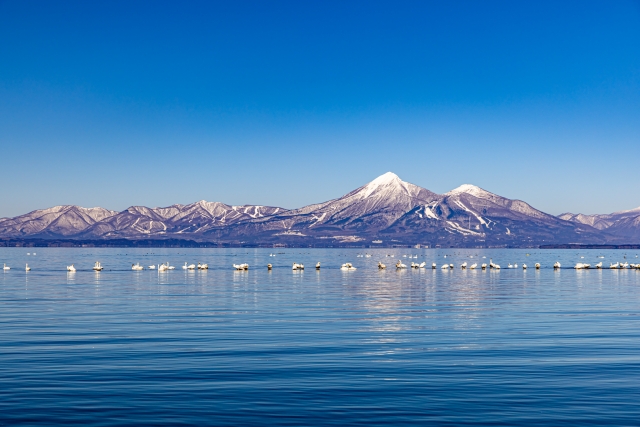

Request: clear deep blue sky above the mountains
left=0, top=0, right=640, bottom=216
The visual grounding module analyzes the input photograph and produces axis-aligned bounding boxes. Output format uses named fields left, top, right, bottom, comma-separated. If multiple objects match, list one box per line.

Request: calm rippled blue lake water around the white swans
left=0, top=248, right=640, bottom=426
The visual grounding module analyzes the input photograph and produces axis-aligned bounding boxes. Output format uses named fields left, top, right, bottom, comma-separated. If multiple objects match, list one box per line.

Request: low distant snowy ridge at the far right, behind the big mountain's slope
left=558, top=207, right=640, bottom=241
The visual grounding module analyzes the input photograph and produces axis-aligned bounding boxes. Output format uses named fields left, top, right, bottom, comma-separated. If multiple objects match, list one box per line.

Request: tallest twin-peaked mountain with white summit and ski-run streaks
left=209, top=173, right=601, bottom=244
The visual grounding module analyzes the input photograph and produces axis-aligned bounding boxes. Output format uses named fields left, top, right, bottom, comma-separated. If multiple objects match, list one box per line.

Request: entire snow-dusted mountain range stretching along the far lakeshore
left=0, top=172, right=640, bottom=247
